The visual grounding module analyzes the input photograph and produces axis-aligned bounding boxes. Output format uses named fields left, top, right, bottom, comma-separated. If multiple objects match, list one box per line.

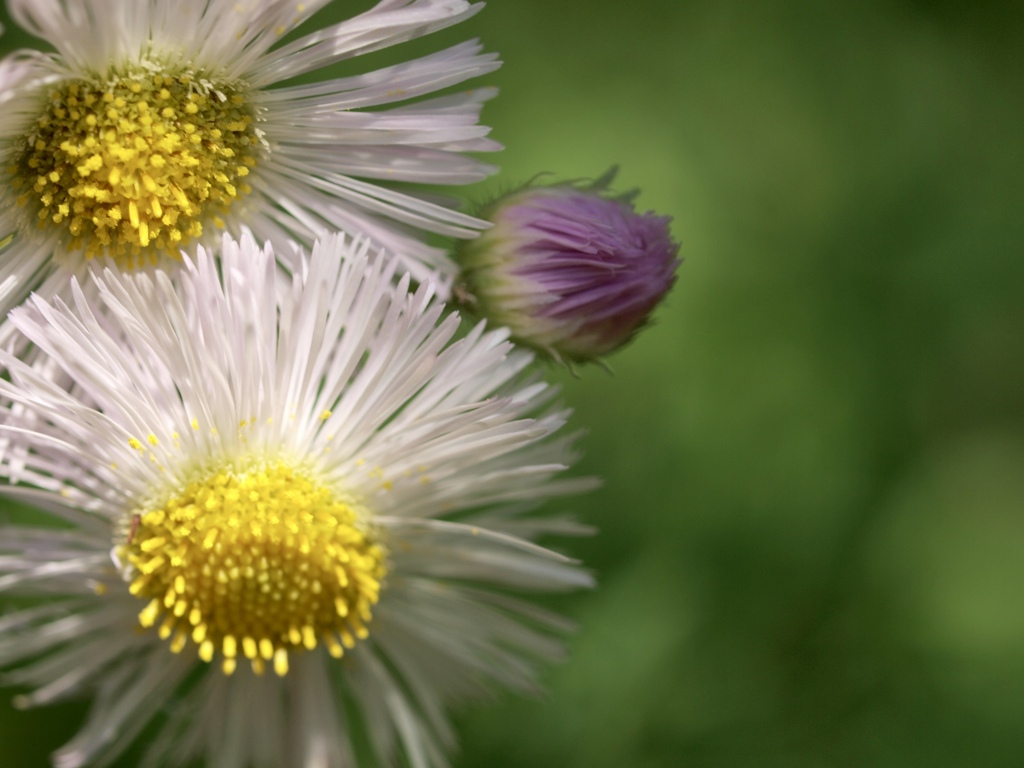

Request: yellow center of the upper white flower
left=10, top=68, right=260, bottom=268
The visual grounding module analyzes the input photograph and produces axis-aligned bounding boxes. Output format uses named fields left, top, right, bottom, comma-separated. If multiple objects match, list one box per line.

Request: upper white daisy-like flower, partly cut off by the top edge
left=0, top=0, right=500, bottom=327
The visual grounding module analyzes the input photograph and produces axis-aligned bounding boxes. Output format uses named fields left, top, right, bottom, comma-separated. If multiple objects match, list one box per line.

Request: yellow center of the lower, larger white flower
left=119, top=462, right=386, bottom=676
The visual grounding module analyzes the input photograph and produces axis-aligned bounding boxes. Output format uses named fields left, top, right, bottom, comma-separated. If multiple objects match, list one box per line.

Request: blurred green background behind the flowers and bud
left=0, top=0, right=1024, bottom=768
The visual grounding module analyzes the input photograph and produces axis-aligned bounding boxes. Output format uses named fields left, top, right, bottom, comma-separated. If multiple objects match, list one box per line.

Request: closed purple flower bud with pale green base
left=460, top=169, right=679, bottom=361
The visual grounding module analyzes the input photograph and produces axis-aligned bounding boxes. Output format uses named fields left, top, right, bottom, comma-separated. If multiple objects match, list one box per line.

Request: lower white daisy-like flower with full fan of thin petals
left=0, top=236, right=590, bottom=768
